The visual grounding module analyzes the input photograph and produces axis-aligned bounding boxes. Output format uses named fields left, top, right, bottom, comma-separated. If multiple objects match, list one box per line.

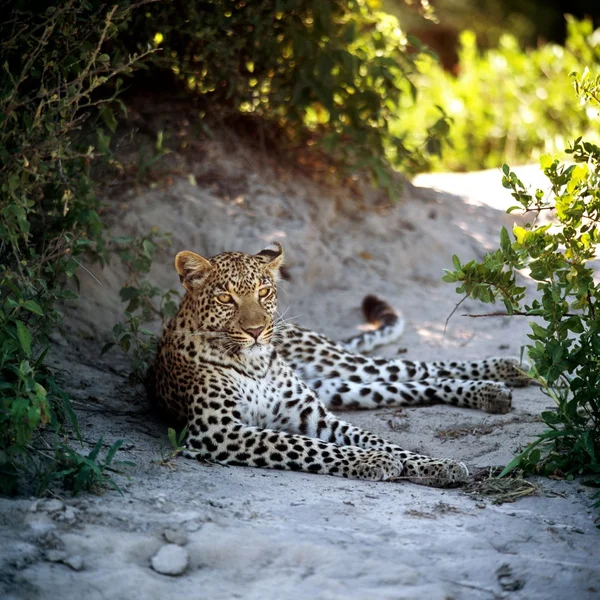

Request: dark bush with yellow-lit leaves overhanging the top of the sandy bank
left=117, top=0, right=447, bottom=192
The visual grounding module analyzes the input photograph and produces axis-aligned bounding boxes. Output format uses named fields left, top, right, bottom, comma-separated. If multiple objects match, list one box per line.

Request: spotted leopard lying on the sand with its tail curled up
left=148, top=242, right=528, bottom=487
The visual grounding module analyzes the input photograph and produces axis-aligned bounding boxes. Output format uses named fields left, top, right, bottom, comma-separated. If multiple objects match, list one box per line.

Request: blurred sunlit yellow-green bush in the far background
left=392, top=17, right=600, bottom=171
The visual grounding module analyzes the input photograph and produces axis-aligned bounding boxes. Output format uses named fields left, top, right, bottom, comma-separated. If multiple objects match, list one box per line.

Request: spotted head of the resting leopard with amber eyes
left=175, top=242, right=283, bottom=353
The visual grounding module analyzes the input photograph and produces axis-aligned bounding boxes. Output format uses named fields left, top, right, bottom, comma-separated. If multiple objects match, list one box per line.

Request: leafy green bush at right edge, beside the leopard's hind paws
left=444, top=70, right=600, bottom=502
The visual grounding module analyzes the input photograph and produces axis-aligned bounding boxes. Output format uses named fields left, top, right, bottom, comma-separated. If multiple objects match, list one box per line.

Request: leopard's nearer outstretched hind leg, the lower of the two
left=307, top=379, right=512, bottom=413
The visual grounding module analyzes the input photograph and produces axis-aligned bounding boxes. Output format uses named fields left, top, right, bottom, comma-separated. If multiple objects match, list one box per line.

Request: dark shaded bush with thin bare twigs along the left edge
left=0, top=0, right=150, bottom=493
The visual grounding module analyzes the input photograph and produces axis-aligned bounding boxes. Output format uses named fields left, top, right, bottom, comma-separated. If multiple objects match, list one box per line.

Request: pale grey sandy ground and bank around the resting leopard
left=0, top=144, right=600, bottom=600
